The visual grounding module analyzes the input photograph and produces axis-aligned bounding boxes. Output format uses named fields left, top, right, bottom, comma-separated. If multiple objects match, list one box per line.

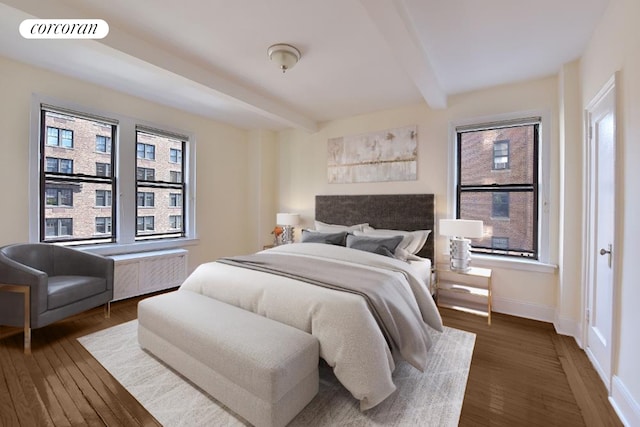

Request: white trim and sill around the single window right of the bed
left=442, top=110, right=557, bottom=273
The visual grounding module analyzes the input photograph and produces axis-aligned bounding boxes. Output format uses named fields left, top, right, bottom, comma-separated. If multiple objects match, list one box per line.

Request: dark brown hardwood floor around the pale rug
left=0, top=299, right=622, bottom=426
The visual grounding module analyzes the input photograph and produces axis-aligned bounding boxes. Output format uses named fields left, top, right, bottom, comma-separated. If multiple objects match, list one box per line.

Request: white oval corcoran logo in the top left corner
left=20, top=19, right=109, bottom=39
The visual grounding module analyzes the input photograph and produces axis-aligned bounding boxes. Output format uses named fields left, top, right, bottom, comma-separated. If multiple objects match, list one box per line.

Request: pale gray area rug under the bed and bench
left=78, top=320, right=475, bottom=427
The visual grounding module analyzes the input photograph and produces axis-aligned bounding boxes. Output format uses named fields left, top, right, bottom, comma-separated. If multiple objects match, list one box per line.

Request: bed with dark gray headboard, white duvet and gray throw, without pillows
left=181, top=194, right=442, bottom=410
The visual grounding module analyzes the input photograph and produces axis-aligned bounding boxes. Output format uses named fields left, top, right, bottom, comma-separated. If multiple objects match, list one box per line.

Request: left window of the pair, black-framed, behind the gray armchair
left=38, top=105, right=116, bottom=243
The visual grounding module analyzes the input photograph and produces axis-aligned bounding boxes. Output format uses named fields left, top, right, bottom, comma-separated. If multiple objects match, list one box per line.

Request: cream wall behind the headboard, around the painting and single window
left=279, top=77, right=560, bottom=321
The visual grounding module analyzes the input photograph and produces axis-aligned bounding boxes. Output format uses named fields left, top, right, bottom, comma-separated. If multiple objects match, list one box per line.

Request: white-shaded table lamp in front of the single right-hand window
left=439, top=219, right=483, bottom=271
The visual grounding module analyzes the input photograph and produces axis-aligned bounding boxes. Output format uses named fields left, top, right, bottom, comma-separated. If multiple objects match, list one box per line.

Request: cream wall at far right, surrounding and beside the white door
left=581, top=0, right=640, bottom=426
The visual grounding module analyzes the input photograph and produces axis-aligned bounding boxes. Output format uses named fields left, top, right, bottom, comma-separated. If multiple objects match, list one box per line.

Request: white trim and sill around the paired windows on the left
left=29, top=94, right=198, bottom=255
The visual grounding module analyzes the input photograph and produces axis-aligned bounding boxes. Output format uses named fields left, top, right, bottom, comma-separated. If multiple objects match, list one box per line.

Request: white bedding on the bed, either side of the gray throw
left=182, top=243, right=442, bottom=410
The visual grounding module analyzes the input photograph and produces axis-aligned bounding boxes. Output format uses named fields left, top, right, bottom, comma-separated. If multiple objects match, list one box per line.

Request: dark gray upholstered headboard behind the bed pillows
left=316, top=194, right=435, bottom=262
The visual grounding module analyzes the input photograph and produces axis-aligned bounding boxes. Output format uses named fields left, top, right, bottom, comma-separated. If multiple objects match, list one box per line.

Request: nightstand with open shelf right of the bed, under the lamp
left=435, top=267, right=492, bottom=325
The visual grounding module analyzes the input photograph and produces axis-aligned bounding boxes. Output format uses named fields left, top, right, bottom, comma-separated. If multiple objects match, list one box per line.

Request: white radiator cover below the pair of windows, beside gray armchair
left=111, top=249, right=188, bottom=301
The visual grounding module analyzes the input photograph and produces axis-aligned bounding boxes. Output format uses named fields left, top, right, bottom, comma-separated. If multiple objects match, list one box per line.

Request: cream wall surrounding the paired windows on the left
left=0, top=57, right=253, bottom=269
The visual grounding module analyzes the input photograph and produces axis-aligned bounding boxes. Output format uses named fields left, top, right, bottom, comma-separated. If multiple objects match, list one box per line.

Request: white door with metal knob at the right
left=585, top=80, right=616, bottom=389
